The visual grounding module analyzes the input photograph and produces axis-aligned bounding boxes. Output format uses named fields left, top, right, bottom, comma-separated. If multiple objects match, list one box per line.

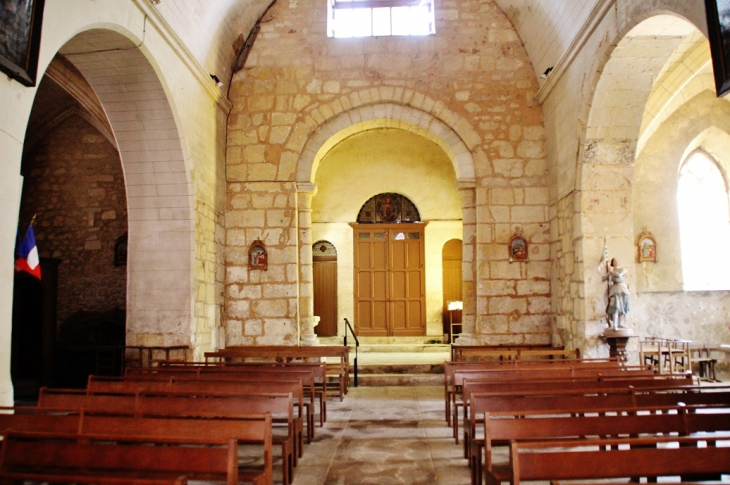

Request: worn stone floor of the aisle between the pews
left=294, top=386, right=470, bottom=485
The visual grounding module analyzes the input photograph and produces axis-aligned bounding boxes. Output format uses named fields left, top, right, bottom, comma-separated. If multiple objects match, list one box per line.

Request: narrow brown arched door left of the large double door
left=312, top=241, right=337, bottom=337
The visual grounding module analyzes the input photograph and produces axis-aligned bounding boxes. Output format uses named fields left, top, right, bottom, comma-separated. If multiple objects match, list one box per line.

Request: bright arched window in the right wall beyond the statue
left=677, top=151, right=730, bottom=291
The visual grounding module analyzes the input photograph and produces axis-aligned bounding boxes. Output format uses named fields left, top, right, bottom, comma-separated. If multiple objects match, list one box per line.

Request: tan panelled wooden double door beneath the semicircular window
left=353, top=224, right=426, bottom=337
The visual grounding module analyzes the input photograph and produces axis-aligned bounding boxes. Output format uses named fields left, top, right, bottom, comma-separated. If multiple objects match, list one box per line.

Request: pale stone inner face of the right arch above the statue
left=557, top=14, right=698, bottom=356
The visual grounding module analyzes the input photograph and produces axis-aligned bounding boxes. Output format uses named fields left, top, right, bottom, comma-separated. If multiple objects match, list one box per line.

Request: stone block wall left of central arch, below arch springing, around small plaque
left=225, top=182, right=299, bottom=346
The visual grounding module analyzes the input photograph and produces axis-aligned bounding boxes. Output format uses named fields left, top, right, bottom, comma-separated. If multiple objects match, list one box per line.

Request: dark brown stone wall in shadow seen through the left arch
left=20, top=116, right=127, bottom=323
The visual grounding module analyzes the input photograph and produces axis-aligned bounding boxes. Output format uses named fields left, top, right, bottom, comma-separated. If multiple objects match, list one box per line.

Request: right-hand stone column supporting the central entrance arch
left=455, top=179, right=478, bottom=345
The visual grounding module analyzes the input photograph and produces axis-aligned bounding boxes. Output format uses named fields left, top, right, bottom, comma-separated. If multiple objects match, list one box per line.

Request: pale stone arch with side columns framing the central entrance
left=296, top=102, right=476, bottom=344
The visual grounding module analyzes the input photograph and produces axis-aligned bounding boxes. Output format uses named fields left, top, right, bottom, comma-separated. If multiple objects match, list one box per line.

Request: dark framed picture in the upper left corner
left=0, top=0, right=44, bottom=86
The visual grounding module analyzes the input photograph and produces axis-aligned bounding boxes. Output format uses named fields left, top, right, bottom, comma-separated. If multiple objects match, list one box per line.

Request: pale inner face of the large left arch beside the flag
left=59, top=29, right=195, bottom=345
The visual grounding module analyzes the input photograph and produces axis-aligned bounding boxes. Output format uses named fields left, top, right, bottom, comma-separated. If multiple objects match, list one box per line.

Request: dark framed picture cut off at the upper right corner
left=705, top=0, right=730, bottom=96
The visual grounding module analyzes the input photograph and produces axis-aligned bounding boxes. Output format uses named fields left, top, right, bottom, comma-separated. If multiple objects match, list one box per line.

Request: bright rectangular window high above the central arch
left=327, top=0, right=436, bottom=37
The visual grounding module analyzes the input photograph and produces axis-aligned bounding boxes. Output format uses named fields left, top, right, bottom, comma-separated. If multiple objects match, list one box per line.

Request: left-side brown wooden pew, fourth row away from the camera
left=86, top=374, right=314, bottom=448
